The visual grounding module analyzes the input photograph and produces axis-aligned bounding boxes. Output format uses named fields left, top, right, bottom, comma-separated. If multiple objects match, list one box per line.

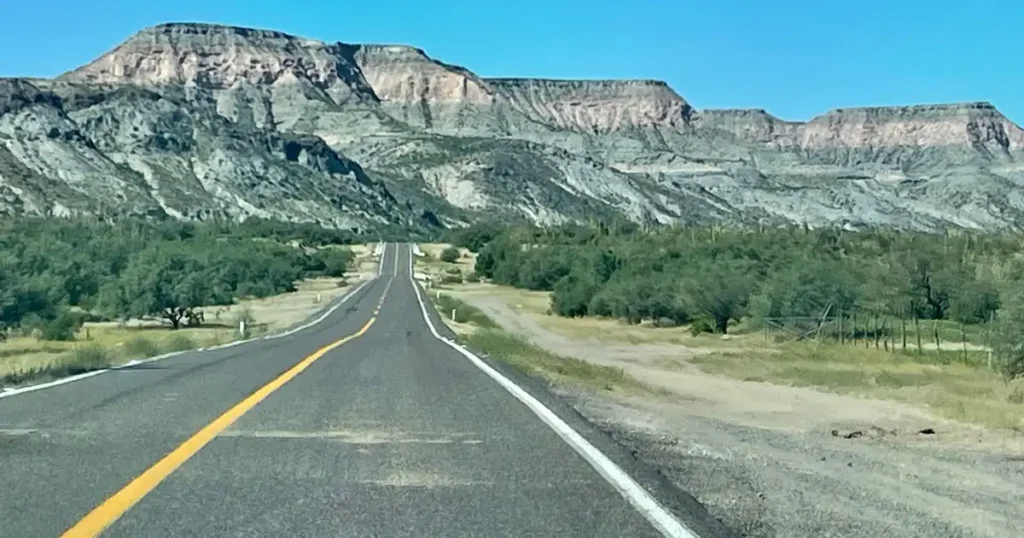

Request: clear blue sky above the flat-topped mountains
left=0, top=0, right=1024, bottom=123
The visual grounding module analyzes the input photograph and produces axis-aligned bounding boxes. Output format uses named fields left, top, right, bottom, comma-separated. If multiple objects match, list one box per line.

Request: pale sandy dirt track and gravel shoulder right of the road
left=450, top=290, right=1024, bottom=538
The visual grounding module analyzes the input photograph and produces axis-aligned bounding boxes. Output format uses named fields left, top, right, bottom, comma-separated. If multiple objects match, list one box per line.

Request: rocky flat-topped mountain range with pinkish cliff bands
left=0, top=24, right=1024, bottom=231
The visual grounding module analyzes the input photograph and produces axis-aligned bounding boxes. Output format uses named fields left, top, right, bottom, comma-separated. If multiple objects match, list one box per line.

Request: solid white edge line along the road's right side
left=409, top=243, right=700, bottom=538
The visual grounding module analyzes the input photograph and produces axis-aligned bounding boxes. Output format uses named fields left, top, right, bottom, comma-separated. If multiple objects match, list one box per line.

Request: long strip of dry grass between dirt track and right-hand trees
left=444, top=284, right=1024, bottom=430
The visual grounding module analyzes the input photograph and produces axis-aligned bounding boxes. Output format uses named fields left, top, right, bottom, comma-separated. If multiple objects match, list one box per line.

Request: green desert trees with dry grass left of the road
left=0, top=217, right=364, bottom=382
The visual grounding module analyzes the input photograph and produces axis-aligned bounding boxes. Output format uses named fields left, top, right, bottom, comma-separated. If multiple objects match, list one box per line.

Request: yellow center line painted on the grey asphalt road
left=61, top=266, right=394, bottom=538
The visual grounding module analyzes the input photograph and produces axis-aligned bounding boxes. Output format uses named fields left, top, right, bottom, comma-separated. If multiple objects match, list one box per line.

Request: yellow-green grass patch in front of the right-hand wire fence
left=691, top=342, right=1024, bottom=431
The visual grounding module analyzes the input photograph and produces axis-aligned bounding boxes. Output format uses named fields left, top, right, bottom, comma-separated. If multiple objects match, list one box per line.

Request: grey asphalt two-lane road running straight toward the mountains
left=0, top=245, right=737, bottom=538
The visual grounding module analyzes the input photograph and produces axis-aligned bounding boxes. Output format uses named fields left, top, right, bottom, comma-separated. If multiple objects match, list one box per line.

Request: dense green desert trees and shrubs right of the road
left=451, top=222, right=1024, bottom=378
